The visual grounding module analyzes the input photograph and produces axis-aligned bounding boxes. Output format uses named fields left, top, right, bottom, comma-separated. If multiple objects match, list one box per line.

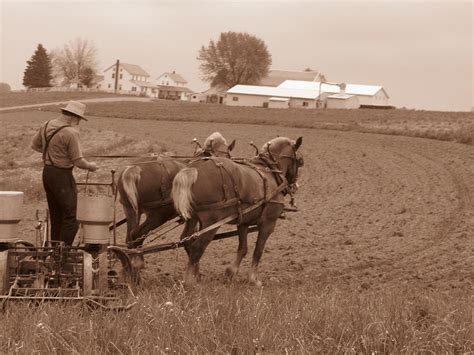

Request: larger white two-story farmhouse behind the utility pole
left=101, top=61, right=158, bottom=97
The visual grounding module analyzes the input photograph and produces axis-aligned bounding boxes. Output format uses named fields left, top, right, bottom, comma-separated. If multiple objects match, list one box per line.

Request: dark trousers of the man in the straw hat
left=43, top=165, right=79, bottom=245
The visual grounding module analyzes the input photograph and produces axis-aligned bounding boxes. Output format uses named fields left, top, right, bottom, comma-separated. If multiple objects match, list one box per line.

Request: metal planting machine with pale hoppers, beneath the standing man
left=0, top=173, right=136, bottom=310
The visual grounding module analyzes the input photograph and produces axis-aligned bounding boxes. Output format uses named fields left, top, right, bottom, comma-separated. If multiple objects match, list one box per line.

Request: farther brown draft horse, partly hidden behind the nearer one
left=117, top=132, right=235, bottom=247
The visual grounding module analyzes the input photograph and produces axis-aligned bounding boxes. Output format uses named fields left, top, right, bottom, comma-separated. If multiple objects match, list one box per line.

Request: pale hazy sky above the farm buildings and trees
left=0, top=0, right=474, bottom=111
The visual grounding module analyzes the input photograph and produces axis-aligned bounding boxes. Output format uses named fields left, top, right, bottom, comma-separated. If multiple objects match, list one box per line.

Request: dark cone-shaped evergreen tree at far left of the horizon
left=23, top=43, right=52, bottom=88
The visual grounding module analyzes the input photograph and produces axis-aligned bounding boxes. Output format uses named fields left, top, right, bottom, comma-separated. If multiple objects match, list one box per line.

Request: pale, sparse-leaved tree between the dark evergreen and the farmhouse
left=52, top=38, right=97, bottom=86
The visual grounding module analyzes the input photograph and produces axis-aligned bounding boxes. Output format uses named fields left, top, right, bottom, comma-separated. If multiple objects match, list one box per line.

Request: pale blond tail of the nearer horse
left=171, top=168, right=198, bottom=219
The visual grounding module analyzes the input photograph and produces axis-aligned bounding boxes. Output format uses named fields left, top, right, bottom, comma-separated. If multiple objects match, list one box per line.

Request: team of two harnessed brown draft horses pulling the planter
left=118, top=132, right=303, bottom=286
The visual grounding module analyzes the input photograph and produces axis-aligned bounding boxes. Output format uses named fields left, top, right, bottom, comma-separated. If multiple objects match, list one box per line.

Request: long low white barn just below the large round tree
left=226, top=85, right=319, bottom=108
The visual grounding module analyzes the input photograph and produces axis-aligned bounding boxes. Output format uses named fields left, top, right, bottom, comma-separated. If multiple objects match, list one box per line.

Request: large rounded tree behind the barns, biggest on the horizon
left=197, top=32, right=272, bottom=88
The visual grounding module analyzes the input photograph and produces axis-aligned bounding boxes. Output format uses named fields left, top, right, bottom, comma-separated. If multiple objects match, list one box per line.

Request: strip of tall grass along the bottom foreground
left=0, top=284, right=474, bottom=354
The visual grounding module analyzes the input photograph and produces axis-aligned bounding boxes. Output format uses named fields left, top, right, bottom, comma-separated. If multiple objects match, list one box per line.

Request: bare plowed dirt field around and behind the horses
left=0, top=111, right=474, bottom=292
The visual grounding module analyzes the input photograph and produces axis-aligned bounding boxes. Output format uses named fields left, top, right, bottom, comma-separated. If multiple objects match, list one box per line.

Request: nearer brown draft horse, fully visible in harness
left=171, top=137, right=303, bottom=286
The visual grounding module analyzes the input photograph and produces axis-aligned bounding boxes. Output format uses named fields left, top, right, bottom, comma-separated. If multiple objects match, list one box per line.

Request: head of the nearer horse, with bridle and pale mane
left=262, top=137, right=304, bottom=186
